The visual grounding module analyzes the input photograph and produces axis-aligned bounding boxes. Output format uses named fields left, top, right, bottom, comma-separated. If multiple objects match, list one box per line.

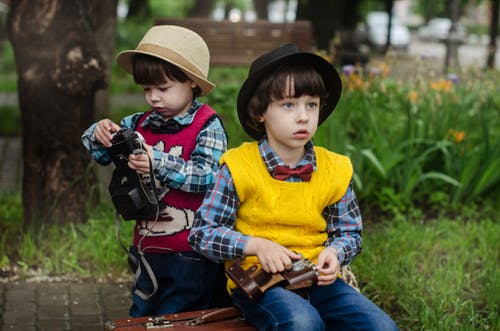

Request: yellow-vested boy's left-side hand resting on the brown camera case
left=245, top=237, right=300, bottom=273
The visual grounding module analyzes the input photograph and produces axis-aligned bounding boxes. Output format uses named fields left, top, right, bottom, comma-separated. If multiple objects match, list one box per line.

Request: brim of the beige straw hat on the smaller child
left=116, top=50, right=215, bottom=95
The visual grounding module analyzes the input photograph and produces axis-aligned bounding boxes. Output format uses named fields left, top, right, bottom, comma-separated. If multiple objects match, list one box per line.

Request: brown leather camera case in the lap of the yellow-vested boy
left=226, top=258, right=318, bottom=300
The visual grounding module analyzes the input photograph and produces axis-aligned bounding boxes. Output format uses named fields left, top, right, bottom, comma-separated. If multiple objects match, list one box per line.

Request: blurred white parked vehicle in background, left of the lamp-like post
left=366, top=11, right=410, bottom=50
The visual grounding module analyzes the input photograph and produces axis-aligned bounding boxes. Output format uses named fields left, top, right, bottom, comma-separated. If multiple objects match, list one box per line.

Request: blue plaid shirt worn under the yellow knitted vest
left=189, top=138, right=362, bottom=265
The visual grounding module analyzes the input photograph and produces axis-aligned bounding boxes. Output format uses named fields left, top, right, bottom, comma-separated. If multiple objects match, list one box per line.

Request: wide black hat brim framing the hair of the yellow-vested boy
left=237, top=52, right=342, bottom=140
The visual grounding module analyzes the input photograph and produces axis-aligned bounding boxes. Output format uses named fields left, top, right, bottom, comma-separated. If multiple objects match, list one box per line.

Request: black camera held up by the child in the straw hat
left=108, top=129, right=160, bottom=220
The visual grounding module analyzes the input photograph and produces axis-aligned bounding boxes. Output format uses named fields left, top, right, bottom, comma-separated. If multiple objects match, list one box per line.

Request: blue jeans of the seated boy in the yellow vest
left=233, top=279, right=398, bottom=331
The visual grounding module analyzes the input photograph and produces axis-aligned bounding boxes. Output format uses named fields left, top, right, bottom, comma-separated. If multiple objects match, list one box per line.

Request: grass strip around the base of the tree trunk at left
left=0, top=193, right=133, bottom=280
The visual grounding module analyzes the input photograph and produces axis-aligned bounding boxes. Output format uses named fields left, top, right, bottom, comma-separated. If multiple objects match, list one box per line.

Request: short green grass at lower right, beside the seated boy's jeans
left=353, top=219, right=500, bottom=331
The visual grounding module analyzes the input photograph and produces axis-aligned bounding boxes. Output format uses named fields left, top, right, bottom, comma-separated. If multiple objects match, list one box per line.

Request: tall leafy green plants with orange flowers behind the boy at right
left=315, top=62, right=500, bottom=218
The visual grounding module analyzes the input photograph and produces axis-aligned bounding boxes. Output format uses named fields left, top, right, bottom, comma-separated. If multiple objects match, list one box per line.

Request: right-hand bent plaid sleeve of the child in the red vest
left=153, top=117, right=227, bottom=193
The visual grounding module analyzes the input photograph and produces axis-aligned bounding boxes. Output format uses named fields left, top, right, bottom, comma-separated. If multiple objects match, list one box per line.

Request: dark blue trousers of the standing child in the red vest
left=129, top=247, right=217, bottom=317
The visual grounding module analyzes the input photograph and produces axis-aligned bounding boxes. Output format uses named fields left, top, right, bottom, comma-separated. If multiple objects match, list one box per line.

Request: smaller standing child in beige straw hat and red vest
left=82, top=25, right=227, bottom=317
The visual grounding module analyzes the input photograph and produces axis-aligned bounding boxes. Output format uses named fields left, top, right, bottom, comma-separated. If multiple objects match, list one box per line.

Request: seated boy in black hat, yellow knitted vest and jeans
left=189, top=44, right=397, bottom=331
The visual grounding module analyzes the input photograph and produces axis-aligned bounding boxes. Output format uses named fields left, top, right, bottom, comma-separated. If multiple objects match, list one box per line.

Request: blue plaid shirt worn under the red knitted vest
left=82, top=100, right=227, bottom=192
